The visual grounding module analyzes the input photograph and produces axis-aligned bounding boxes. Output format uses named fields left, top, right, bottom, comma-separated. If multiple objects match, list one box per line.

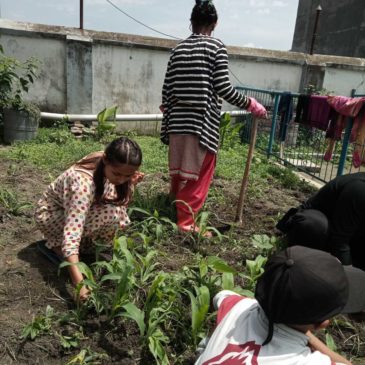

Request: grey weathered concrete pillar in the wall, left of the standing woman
left=66, top=35, right=93, bottom=114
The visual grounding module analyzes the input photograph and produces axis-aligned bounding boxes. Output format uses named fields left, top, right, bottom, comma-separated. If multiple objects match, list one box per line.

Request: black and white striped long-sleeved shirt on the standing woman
left=161, top=34, right=250, bottom=153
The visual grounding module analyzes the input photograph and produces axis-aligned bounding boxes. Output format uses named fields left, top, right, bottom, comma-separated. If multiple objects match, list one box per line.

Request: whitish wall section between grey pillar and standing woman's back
left=93, top=43, right=169, bottom=114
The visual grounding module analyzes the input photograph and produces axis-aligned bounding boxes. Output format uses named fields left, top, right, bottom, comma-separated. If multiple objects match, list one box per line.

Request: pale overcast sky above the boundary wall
left=0, top=0, right=298, bottom=50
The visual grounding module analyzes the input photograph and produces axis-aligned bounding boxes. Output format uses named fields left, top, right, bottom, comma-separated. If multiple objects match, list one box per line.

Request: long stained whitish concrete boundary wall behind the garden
left=0, top=19, right=365, bottom=118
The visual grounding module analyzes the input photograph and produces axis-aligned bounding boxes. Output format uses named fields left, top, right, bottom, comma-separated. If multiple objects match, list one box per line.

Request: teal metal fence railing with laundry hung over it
left=237, top=87, right=365, bottom=182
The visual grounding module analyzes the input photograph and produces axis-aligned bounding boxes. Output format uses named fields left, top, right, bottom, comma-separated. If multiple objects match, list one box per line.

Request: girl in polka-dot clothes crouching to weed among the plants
left=35, top=137, right=143, bottom=299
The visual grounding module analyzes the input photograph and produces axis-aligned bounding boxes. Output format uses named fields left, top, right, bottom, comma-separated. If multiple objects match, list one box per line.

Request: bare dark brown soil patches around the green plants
left=0, top=160, right=365, bottom=365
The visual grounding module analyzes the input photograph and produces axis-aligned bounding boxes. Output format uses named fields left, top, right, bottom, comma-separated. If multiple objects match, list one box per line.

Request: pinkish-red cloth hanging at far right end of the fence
left=327, top=96, right=365, bottom=168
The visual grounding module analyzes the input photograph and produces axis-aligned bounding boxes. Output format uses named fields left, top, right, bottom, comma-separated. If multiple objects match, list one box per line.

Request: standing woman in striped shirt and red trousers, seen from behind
left=160, top=0, right=266, bottom=231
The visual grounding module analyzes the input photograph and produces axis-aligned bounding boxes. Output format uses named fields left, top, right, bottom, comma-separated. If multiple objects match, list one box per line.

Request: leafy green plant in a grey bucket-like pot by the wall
left=0, top=45, right=40, bottom=143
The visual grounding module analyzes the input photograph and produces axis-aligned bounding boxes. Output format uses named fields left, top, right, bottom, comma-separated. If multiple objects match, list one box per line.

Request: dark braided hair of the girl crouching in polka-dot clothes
left=75, top=137, right=142, bottom=205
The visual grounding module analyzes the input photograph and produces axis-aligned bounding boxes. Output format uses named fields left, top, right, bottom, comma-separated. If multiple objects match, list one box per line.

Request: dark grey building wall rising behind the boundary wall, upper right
left=292, top=0, right=365, bottom=57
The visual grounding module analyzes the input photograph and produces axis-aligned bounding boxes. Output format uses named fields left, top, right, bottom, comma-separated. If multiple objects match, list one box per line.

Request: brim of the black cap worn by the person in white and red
left=341, top=266, right=365, bottom=313
